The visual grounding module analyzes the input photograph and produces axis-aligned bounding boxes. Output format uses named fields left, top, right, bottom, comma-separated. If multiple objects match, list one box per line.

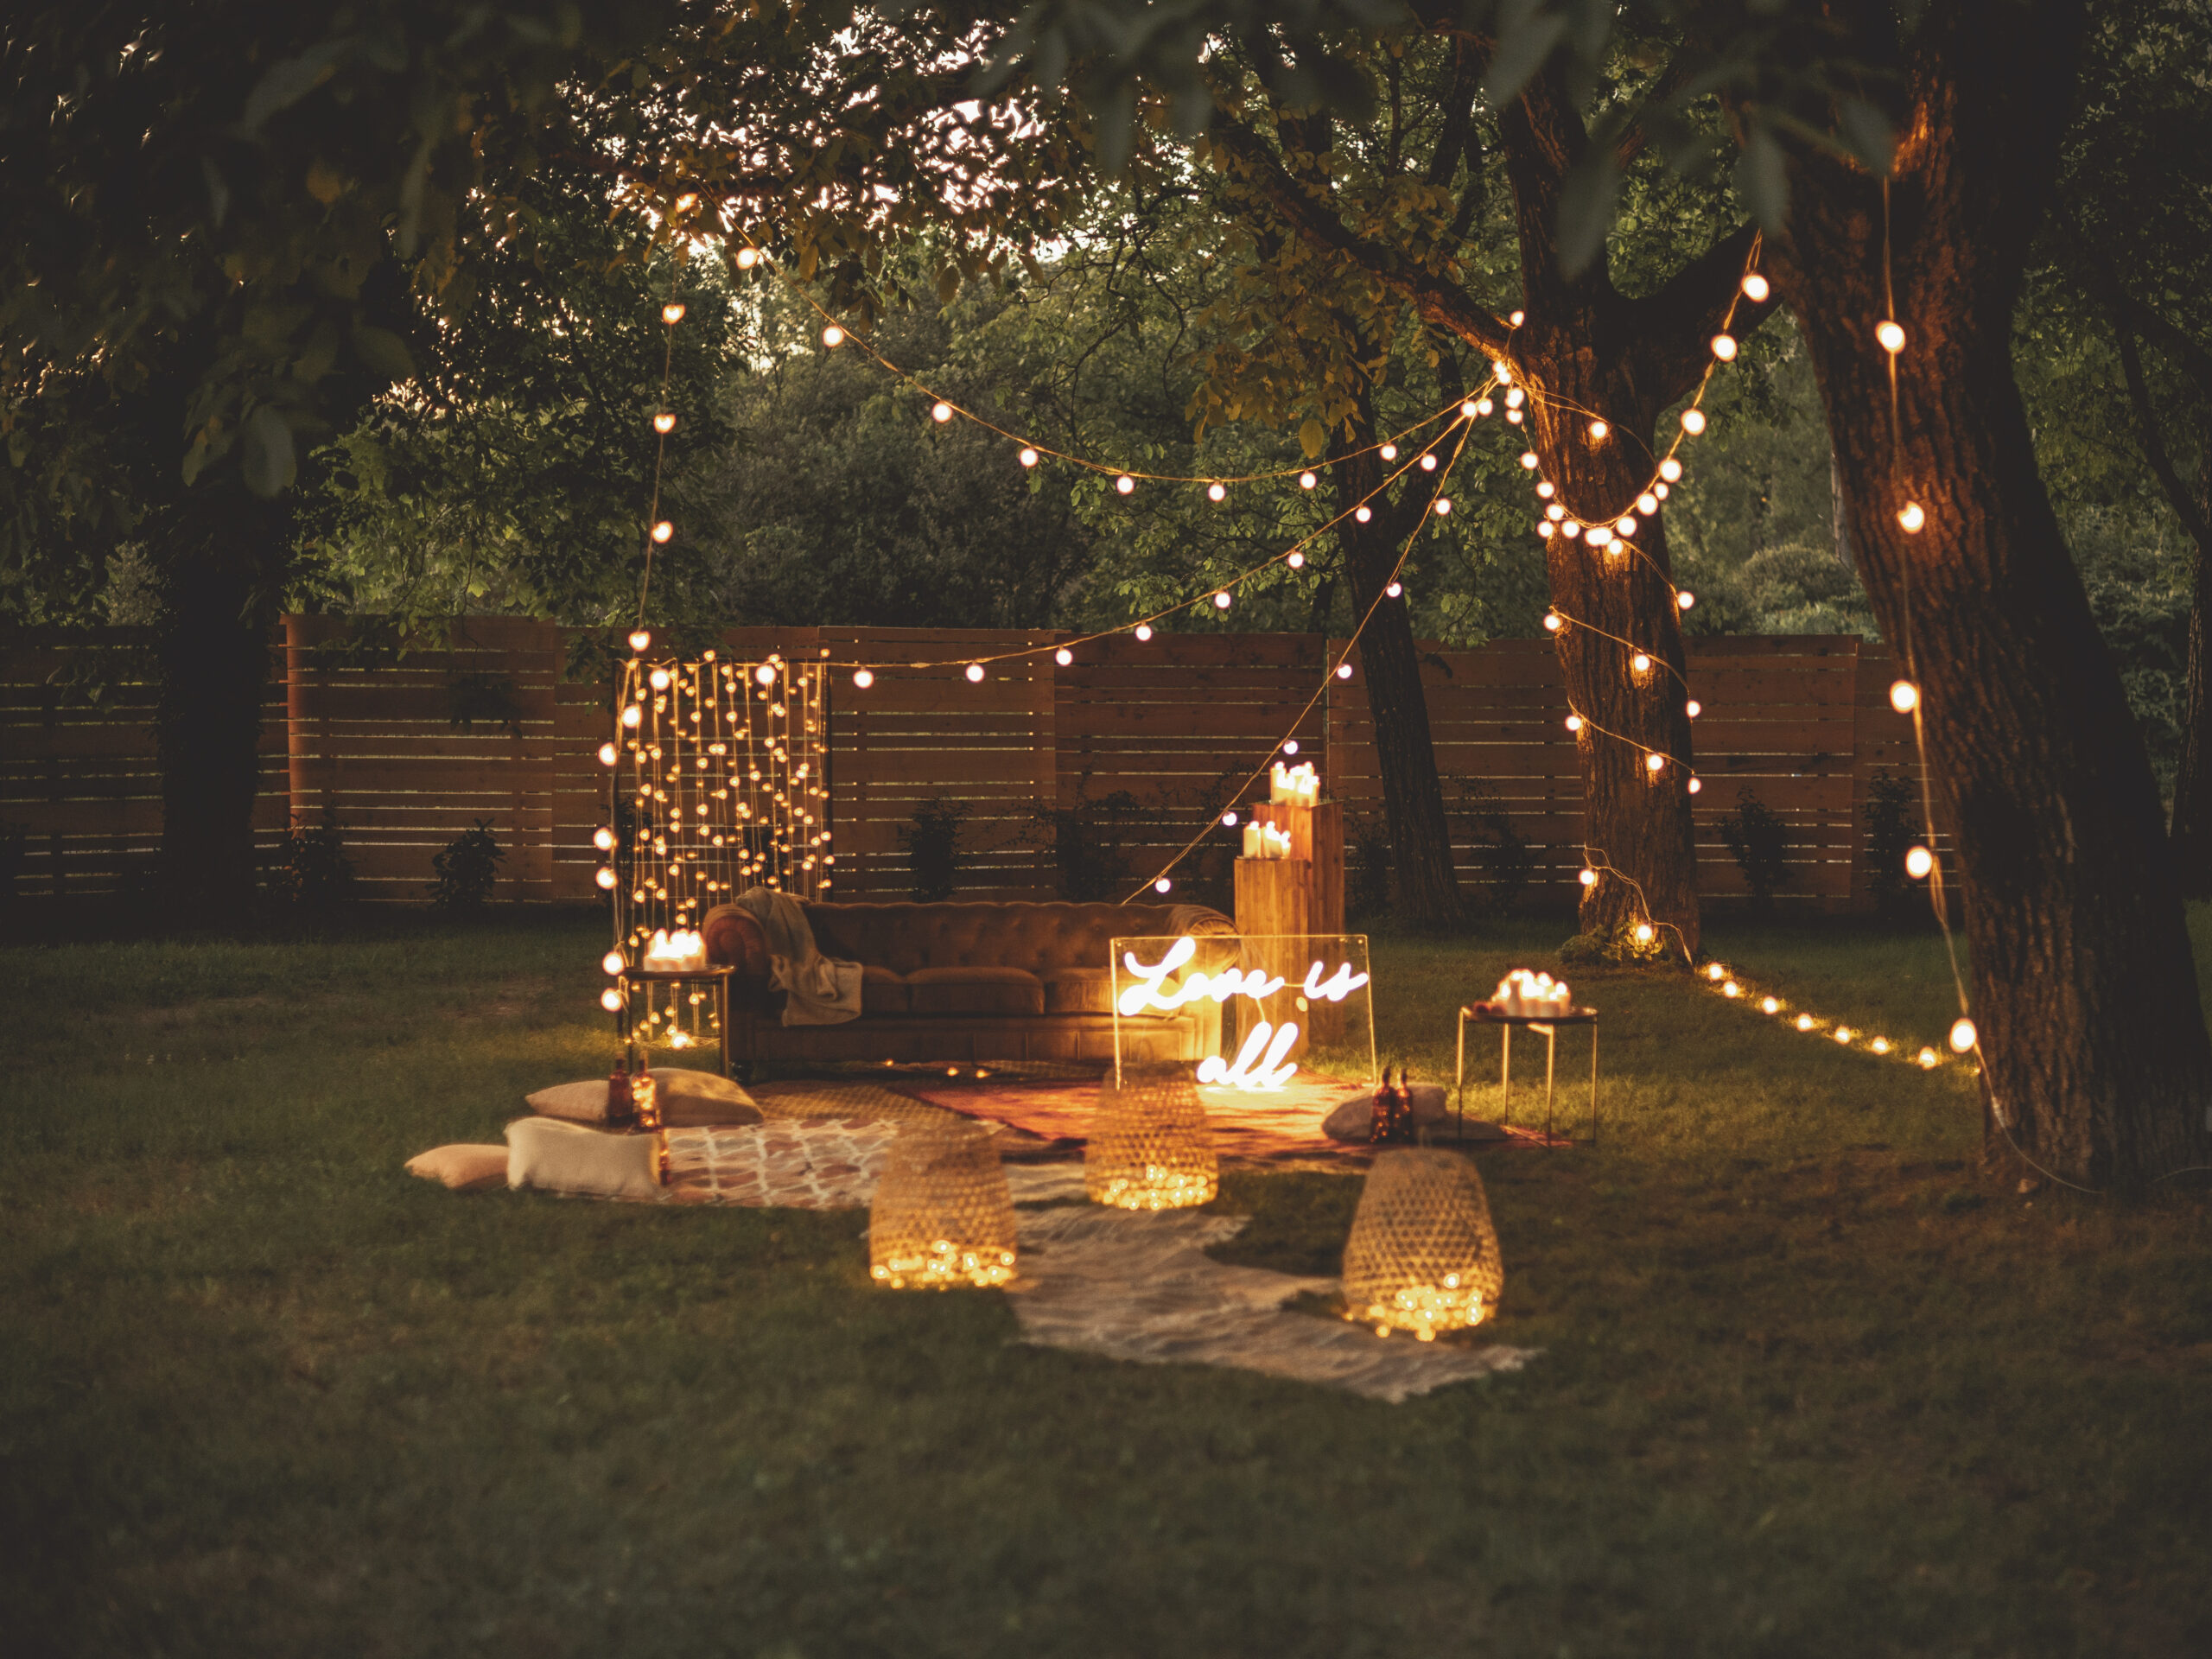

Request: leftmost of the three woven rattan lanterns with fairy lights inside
left=868, top=1117, right=1013, bottom=1289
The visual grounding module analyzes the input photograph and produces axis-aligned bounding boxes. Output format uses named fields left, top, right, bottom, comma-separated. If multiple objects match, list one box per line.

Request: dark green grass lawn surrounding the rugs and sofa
left=0, top=918, right=2212, bottom=1659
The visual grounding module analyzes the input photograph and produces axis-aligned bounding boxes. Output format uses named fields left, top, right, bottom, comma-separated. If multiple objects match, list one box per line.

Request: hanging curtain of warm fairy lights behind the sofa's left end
left=595, top=651, right=836, bottom=1048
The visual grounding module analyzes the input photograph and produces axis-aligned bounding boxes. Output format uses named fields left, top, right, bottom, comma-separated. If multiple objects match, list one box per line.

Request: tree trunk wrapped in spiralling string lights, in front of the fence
left=1516, top=334, right=1701, bottom=960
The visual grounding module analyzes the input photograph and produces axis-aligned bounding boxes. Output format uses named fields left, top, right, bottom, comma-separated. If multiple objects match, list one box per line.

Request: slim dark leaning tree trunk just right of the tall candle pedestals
left=1330, top=417, right=1466, bottom=933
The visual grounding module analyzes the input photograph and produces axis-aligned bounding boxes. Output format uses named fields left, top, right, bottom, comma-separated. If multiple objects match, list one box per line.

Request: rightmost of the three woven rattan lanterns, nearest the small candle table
left=1344, top=1148, right=1506, bottom=1343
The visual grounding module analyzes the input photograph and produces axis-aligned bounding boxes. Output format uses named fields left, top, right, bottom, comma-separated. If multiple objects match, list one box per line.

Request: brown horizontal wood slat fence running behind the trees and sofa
left=0, top=617, right=1918, bottom=912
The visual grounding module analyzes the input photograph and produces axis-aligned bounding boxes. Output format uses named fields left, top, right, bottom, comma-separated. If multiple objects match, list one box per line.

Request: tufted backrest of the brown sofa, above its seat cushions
left=807, top=902, right=1236, bottom=978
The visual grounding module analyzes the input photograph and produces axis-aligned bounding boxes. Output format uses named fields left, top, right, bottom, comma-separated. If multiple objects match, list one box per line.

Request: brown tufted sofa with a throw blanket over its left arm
left=702, top=902, right=1236, bottom=1062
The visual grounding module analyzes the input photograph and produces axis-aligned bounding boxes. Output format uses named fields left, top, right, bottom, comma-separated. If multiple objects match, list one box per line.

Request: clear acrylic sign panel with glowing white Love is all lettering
left=1109, top=933, right=1376, bottom=1095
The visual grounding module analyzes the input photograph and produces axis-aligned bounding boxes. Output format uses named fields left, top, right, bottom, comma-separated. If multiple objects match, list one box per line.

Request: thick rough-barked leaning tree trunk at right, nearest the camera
left=1774, top=0, right=2212, bottom=1190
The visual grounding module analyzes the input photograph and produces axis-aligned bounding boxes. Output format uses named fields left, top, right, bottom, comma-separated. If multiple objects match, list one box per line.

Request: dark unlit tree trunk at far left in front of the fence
left=153, top=478, right=292, bottom=927
